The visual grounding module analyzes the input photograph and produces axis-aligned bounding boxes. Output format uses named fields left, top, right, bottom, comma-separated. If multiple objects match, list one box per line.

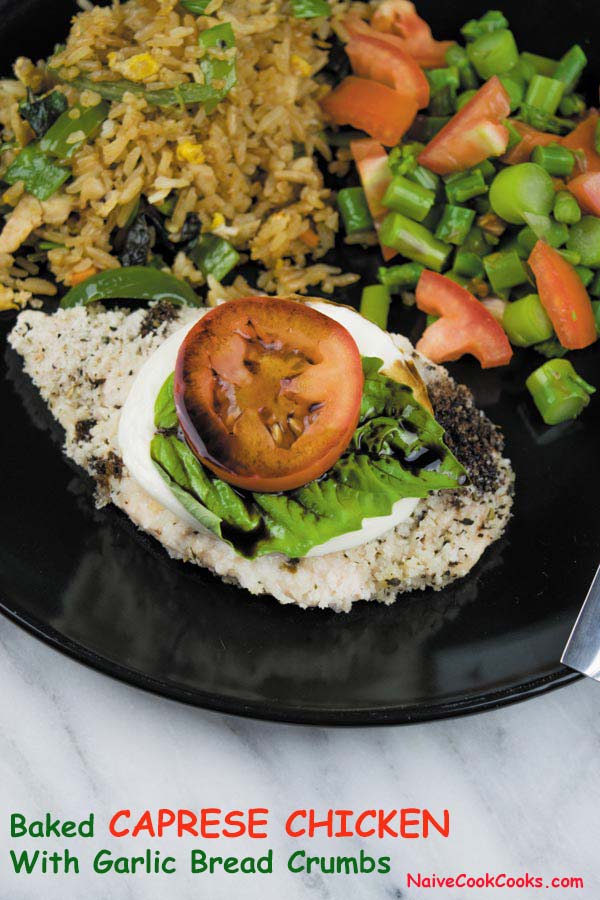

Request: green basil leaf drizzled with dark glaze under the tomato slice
left=152, top=358, right=467, bottom=558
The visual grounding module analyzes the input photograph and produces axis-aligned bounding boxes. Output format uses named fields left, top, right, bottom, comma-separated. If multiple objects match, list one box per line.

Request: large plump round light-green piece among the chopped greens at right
left=489, top=163, right=554, bottom=225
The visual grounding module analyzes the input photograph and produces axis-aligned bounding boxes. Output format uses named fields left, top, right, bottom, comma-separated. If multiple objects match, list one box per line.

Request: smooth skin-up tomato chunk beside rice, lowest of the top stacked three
left=321, top=75, right=418, bottom=147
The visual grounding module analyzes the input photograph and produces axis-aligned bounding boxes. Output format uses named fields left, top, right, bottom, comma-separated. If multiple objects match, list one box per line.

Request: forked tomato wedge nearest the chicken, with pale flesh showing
left=417, top=269, right=513, bottom=369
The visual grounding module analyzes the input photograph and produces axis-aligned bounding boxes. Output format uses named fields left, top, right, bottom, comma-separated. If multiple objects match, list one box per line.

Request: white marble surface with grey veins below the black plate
left=0, top=619, right=600, bottom=900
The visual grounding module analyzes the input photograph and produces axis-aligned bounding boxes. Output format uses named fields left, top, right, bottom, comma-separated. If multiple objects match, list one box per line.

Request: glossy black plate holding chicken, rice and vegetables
left=0, top=0, right=600, bottom=724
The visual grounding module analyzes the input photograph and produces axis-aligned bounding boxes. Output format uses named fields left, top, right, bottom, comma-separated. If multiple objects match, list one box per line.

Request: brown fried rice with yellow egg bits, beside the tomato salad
left=0, top=0, right=361, bottom=309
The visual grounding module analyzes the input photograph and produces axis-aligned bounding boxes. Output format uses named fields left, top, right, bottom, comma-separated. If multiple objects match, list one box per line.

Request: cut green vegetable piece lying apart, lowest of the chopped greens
left=525, top=359, right=596, bottom=425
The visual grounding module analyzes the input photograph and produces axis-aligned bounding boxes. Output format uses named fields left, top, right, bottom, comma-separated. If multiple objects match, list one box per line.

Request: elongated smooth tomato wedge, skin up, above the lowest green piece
left=529, top=241, right=598, bottom=350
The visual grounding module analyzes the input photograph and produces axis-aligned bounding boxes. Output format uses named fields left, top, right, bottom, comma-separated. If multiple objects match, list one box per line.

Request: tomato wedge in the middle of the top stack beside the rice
left=344, top=15, right=429, bottom=109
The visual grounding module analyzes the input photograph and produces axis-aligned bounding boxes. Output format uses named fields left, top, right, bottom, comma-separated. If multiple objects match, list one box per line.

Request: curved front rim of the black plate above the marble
left=0, top=596, right=583, bottom=727
